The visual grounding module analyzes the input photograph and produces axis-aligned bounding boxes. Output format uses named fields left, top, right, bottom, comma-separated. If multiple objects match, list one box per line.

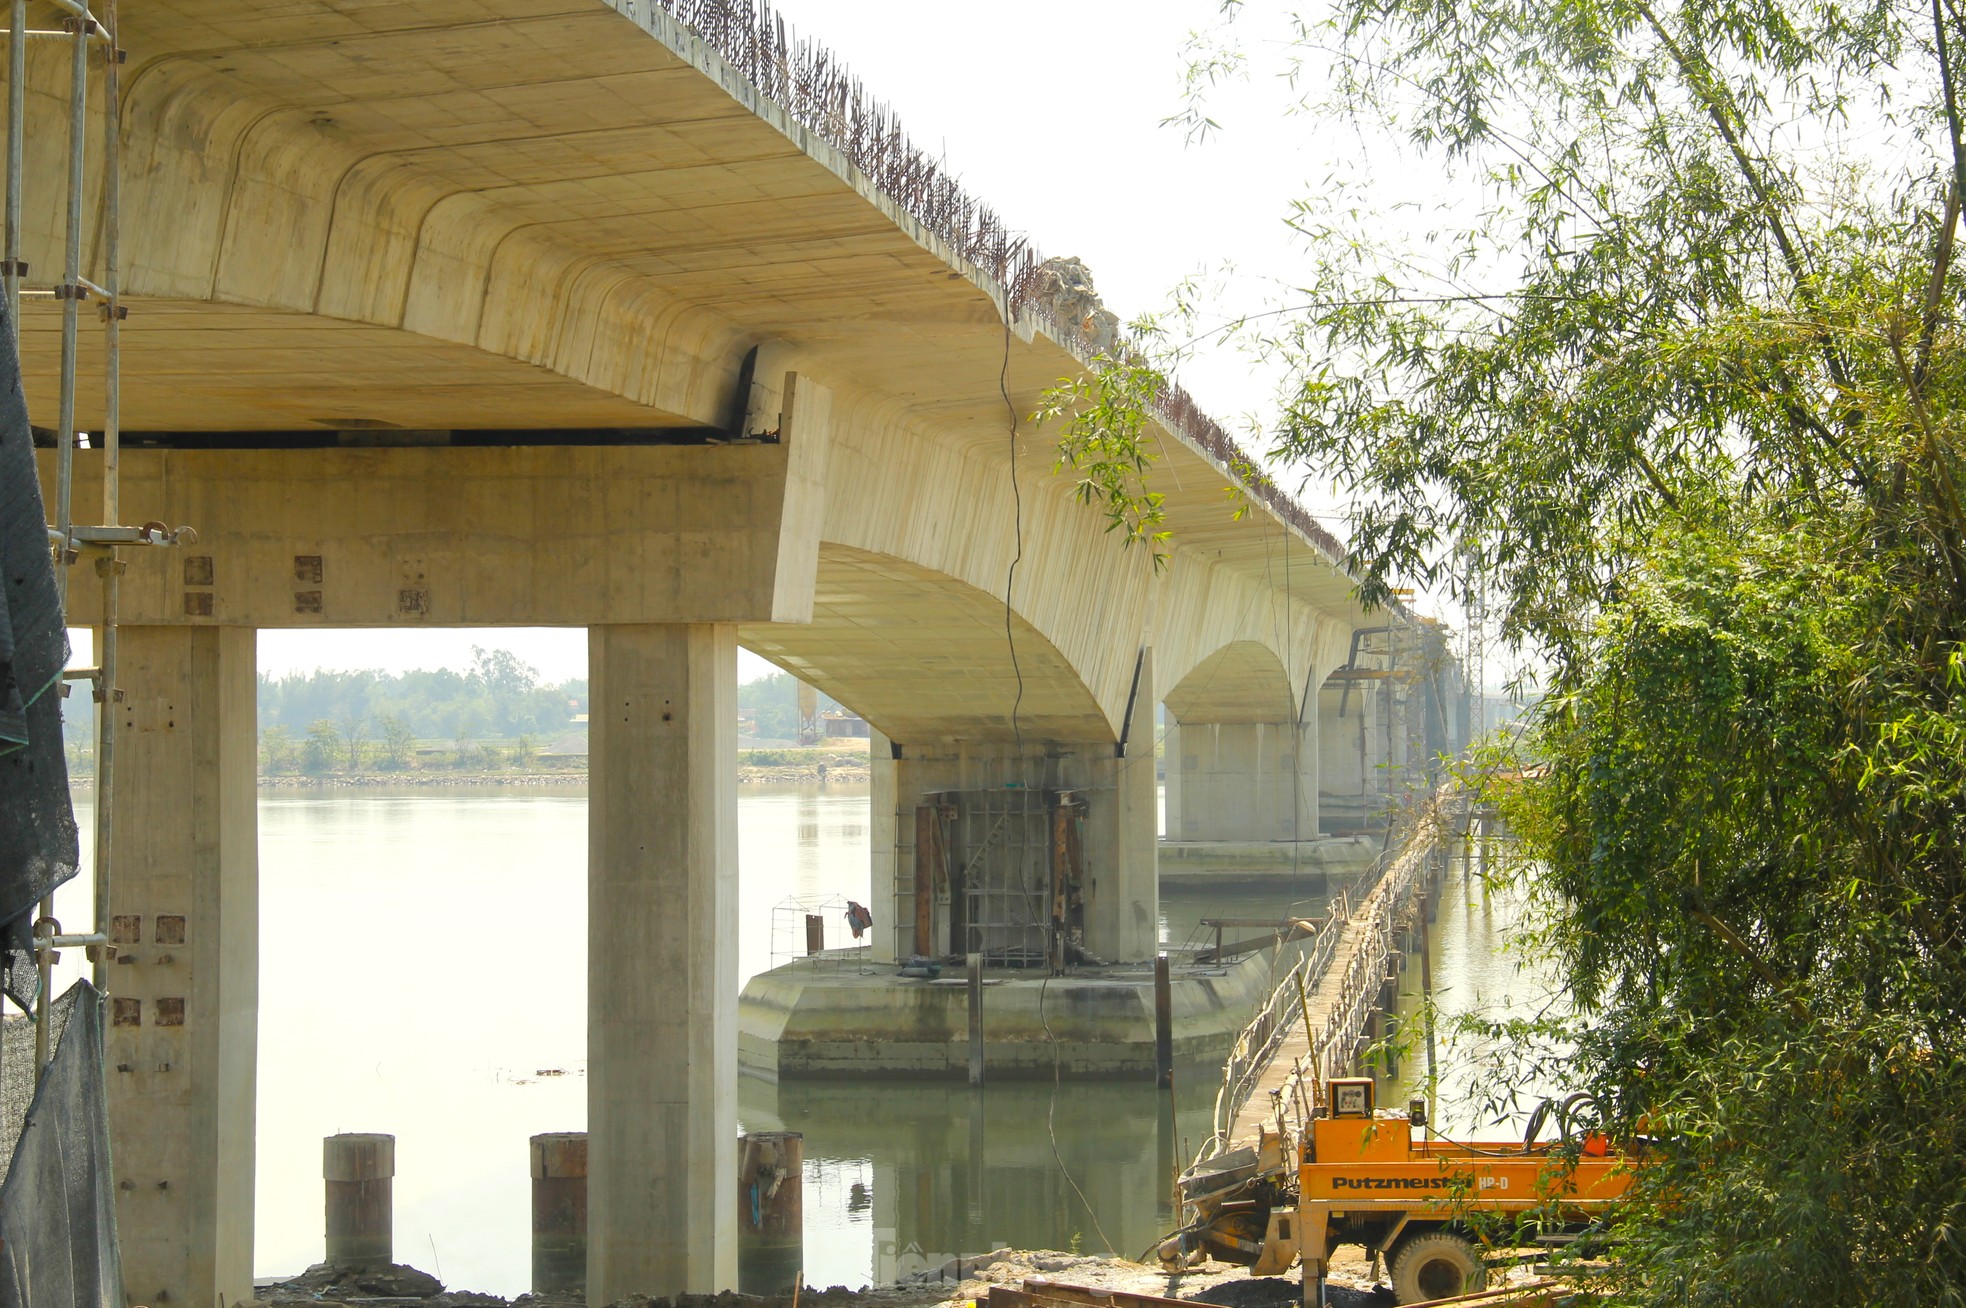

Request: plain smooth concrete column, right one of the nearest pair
left=588, top=624, right=737, bottom=1304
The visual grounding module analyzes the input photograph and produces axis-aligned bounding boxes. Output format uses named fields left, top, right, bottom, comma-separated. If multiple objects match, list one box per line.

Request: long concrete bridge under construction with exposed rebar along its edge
left=18, top=0, right=1453, bottom=1308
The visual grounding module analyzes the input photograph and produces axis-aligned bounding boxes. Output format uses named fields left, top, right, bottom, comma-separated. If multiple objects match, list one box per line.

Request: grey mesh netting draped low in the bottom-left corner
left=0, top=981, right=124, bottom=1308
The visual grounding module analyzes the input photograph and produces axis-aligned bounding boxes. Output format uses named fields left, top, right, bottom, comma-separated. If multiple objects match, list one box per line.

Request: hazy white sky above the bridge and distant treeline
left=233, top=0, right=1427, bottom=681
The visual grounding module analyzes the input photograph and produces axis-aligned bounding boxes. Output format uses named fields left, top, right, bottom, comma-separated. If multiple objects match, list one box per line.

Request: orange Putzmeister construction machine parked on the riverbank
left=1160, top=1078, right=1636, bottom=1304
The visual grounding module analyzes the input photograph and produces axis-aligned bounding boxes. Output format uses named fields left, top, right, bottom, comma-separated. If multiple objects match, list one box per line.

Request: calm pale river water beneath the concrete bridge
left=57, top=785, right=1512, bottom=1296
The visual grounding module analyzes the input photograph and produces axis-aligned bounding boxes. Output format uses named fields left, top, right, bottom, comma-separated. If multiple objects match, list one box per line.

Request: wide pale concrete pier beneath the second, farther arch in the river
left=1162, top=714, right=1319, bottom=840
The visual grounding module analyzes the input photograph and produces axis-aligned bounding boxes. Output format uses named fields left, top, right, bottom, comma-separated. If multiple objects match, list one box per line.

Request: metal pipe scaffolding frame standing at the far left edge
left=0, top=0, right=197, bottom=1074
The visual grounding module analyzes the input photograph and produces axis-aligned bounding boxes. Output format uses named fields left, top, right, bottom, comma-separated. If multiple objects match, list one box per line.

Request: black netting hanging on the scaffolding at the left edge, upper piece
left=0, top=293, right=79, bottom=1005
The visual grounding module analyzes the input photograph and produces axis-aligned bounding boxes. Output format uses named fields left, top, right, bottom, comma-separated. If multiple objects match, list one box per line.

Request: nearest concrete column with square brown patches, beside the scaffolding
left=104, top=625, right=260, bottom=1308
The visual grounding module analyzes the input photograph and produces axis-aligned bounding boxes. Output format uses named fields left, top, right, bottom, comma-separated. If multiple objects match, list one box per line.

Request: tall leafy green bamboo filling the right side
left=1093, top=0, right=1966, bottom=1306
